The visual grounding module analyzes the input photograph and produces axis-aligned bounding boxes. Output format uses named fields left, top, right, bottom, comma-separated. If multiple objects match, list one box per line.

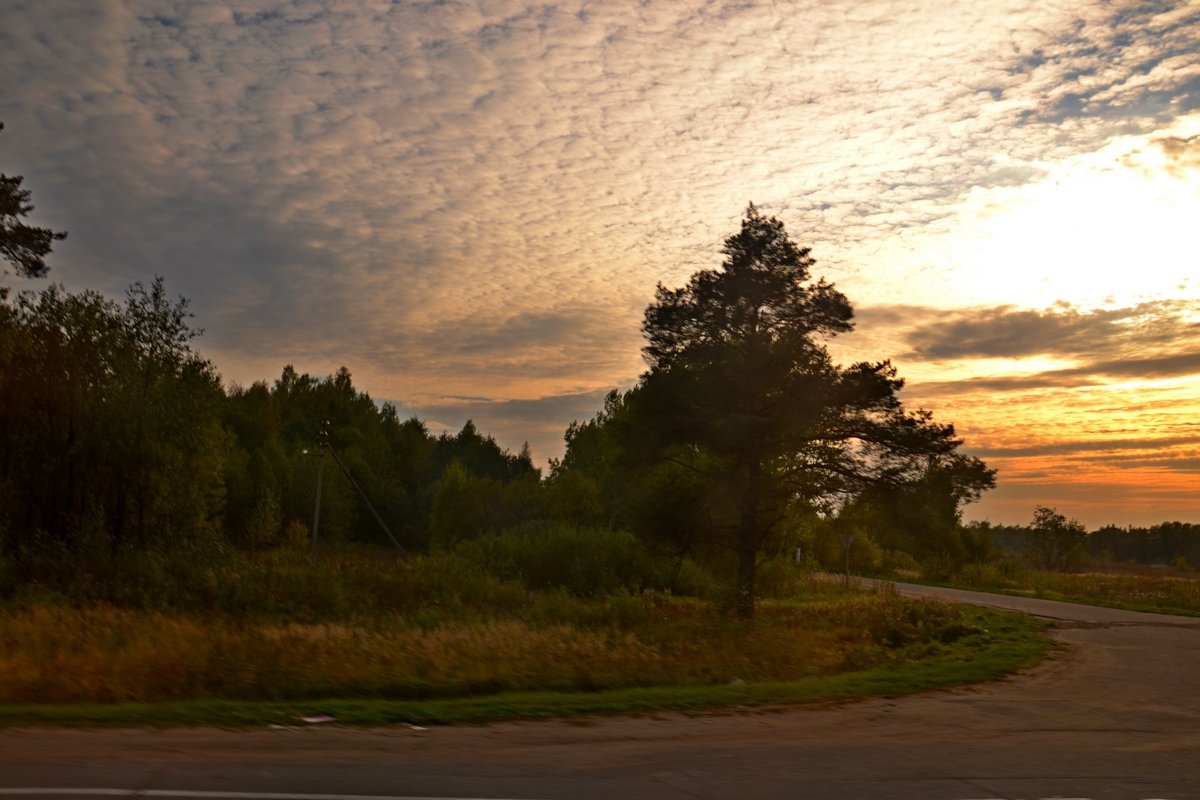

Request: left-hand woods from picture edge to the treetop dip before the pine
left=0, top=279, right=541, bottom=568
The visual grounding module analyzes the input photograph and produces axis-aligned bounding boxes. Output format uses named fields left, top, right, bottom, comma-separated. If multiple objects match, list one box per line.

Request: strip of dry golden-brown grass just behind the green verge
left=0, top=594, right=958, bottom=703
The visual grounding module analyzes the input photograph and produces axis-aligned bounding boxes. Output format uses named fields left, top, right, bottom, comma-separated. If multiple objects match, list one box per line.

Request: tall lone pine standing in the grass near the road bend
left=632, top=205, right=991, bottom=618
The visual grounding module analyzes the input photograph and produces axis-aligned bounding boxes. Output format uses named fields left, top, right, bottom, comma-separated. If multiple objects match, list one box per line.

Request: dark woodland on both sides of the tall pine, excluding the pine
left=0, top=279, right=990, bottom=606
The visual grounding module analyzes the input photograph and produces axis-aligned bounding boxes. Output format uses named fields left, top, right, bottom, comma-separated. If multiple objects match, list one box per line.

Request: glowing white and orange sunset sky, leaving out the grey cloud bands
left=840, top=114, right=1200, bottom=527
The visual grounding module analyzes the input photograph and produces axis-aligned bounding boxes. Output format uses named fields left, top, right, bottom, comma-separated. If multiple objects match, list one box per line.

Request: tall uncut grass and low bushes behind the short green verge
left=0, top=527, right=1046, bottom=704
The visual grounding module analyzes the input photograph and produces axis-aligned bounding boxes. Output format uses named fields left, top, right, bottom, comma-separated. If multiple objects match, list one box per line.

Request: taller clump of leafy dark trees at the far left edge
left=0, top=278, right=224, bottom=566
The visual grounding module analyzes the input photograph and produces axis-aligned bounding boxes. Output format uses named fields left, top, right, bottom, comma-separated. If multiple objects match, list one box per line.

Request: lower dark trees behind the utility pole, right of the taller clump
left=226, top=366, right=541, bottom=551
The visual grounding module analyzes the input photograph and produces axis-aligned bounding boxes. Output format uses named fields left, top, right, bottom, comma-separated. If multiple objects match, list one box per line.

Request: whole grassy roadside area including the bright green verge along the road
left=0, top=544, right=1050, bottom=724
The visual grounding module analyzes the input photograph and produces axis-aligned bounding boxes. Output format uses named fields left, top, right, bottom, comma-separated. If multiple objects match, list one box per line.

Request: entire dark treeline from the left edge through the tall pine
left=0, top=205, right=1017, bottom=618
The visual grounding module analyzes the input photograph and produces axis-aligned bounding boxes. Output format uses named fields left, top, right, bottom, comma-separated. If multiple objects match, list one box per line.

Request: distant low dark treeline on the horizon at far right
left=974, top=522, right=1200, bottom=567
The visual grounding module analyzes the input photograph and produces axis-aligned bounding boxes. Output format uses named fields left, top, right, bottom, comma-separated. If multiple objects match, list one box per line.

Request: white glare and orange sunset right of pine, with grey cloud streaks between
left=854, top=114, right=1200, bottom=527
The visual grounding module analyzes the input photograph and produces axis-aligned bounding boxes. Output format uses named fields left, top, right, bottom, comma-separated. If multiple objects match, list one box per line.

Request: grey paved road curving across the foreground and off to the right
left=0, top=587, right=1200, bottom=800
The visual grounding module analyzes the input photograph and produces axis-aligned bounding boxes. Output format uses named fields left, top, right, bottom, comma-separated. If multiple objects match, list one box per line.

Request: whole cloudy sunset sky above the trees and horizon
left=0, top=0, right=1200, bottom=528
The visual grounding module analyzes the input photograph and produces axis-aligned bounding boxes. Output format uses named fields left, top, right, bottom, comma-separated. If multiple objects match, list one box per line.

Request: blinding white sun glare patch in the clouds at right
left=926, top=115, right=1200, bottom=307
